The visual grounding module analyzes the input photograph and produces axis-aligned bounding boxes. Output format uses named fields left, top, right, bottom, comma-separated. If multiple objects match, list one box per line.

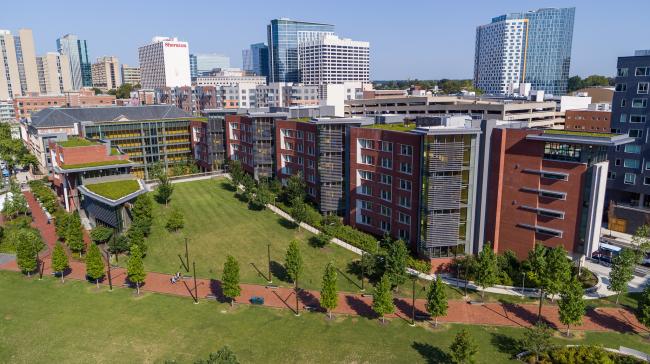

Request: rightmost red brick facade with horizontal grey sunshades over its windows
left=485, top=128, right=587, bottom=259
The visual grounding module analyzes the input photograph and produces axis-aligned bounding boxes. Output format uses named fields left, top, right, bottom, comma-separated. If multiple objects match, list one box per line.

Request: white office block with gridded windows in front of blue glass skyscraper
left=298, top=34, right=370, bottom=97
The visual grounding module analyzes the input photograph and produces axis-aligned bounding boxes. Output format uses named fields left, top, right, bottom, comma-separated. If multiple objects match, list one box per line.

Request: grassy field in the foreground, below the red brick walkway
left=0, top=272, right=650, bottom=364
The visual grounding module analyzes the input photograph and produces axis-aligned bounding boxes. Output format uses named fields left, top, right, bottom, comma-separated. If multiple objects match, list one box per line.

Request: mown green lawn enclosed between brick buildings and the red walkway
left=144, top=179, right=359, bottom=291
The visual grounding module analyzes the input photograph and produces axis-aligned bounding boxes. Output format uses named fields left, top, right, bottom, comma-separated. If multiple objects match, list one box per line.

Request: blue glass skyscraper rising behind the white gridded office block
left=267, top=19, right=334, bottom=82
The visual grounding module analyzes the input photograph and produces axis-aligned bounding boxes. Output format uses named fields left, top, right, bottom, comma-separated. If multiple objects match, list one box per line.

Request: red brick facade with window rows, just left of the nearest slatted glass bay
left=347, top=128, right=422, bottom=251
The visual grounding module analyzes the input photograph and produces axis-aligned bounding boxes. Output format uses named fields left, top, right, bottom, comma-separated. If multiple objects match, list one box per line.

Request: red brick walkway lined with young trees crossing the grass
left=0, top=194, right=646, bottom=332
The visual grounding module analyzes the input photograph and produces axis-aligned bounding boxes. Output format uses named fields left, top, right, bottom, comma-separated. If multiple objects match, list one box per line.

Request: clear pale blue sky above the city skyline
left=0, top=0, right=650, bottom=80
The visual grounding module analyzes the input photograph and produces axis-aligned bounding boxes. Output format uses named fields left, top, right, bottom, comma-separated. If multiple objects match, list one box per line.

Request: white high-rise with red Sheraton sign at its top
left=138, top=37, right=192, bottom=89
